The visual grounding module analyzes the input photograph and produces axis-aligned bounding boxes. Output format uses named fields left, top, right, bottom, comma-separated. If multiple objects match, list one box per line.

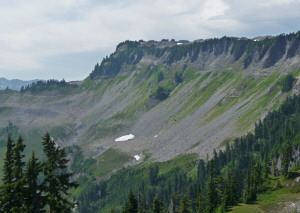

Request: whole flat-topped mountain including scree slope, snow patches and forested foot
left=0, top=32, right=300, bottom=212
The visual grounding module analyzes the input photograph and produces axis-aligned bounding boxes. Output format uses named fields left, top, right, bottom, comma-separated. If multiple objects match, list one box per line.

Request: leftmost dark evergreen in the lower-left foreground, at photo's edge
left=0, top=135, right=15, bottom=212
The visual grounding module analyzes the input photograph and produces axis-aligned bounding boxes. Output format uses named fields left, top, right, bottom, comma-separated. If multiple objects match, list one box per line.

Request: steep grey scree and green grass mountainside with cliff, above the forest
left=0, top=32, right=300, bottom=163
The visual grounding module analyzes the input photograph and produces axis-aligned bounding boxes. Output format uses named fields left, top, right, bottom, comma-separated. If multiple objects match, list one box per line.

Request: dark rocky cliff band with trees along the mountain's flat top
left=90, top=32, right=300, bottom=79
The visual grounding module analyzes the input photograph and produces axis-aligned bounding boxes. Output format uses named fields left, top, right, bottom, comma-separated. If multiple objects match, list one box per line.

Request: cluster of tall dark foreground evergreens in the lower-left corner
left=0, top=133, right=78, bottom=213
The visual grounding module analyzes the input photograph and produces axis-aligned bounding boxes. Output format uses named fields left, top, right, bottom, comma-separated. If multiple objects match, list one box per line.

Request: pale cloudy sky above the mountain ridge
left=0, top=0, right=300, bottom=81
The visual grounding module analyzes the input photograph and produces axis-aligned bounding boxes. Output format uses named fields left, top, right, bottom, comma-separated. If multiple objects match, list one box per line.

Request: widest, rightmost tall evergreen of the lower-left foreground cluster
left=42, top=133, right=77, bottom=213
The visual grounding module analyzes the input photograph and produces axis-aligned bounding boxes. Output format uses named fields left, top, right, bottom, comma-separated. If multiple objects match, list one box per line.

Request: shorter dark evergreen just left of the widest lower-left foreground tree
left=24, top=152, right=45, bottom=213
